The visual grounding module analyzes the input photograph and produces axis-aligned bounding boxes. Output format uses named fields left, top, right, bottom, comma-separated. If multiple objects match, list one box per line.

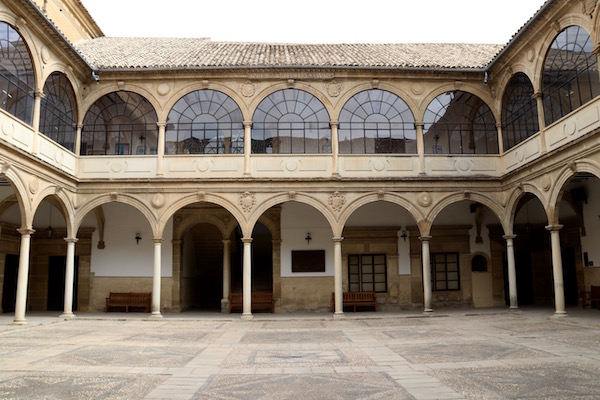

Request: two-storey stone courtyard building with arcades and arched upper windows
left=0, top=0, right=600, bottom=323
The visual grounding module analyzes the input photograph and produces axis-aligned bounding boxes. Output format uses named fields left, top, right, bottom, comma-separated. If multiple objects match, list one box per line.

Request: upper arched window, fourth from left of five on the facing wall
left=339, top=89, right=417, bottom=154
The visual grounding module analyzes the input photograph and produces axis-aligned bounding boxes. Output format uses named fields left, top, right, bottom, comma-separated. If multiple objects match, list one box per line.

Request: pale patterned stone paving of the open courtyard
left=0, top=309, right=600, bottom=400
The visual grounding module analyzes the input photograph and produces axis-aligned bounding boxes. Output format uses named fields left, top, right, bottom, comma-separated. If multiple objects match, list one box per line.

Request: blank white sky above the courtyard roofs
left=82, top=0, right=545, bottom=44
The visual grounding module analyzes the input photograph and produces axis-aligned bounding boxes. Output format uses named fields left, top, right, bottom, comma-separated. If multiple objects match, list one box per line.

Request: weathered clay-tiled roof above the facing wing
left=75, top=37, right=502, bottom=69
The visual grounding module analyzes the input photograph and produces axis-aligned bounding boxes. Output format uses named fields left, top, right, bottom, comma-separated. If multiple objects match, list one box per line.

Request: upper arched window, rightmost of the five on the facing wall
left=423, top=90, right=498, bottom=154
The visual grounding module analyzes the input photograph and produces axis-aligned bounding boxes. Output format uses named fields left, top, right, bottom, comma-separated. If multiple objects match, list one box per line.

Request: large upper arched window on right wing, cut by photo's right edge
left=542, top=25, right=600, bottom=125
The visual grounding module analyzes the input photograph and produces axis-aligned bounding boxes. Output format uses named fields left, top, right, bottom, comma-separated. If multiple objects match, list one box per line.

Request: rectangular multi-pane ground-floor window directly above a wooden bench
left=348, top=254, right=387, bottom=293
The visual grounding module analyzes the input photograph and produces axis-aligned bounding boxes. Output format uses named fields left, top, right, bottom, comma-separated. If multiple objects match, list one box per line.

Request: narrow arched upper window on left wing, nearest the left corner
left=40, top=72, right=77, bottom=151
